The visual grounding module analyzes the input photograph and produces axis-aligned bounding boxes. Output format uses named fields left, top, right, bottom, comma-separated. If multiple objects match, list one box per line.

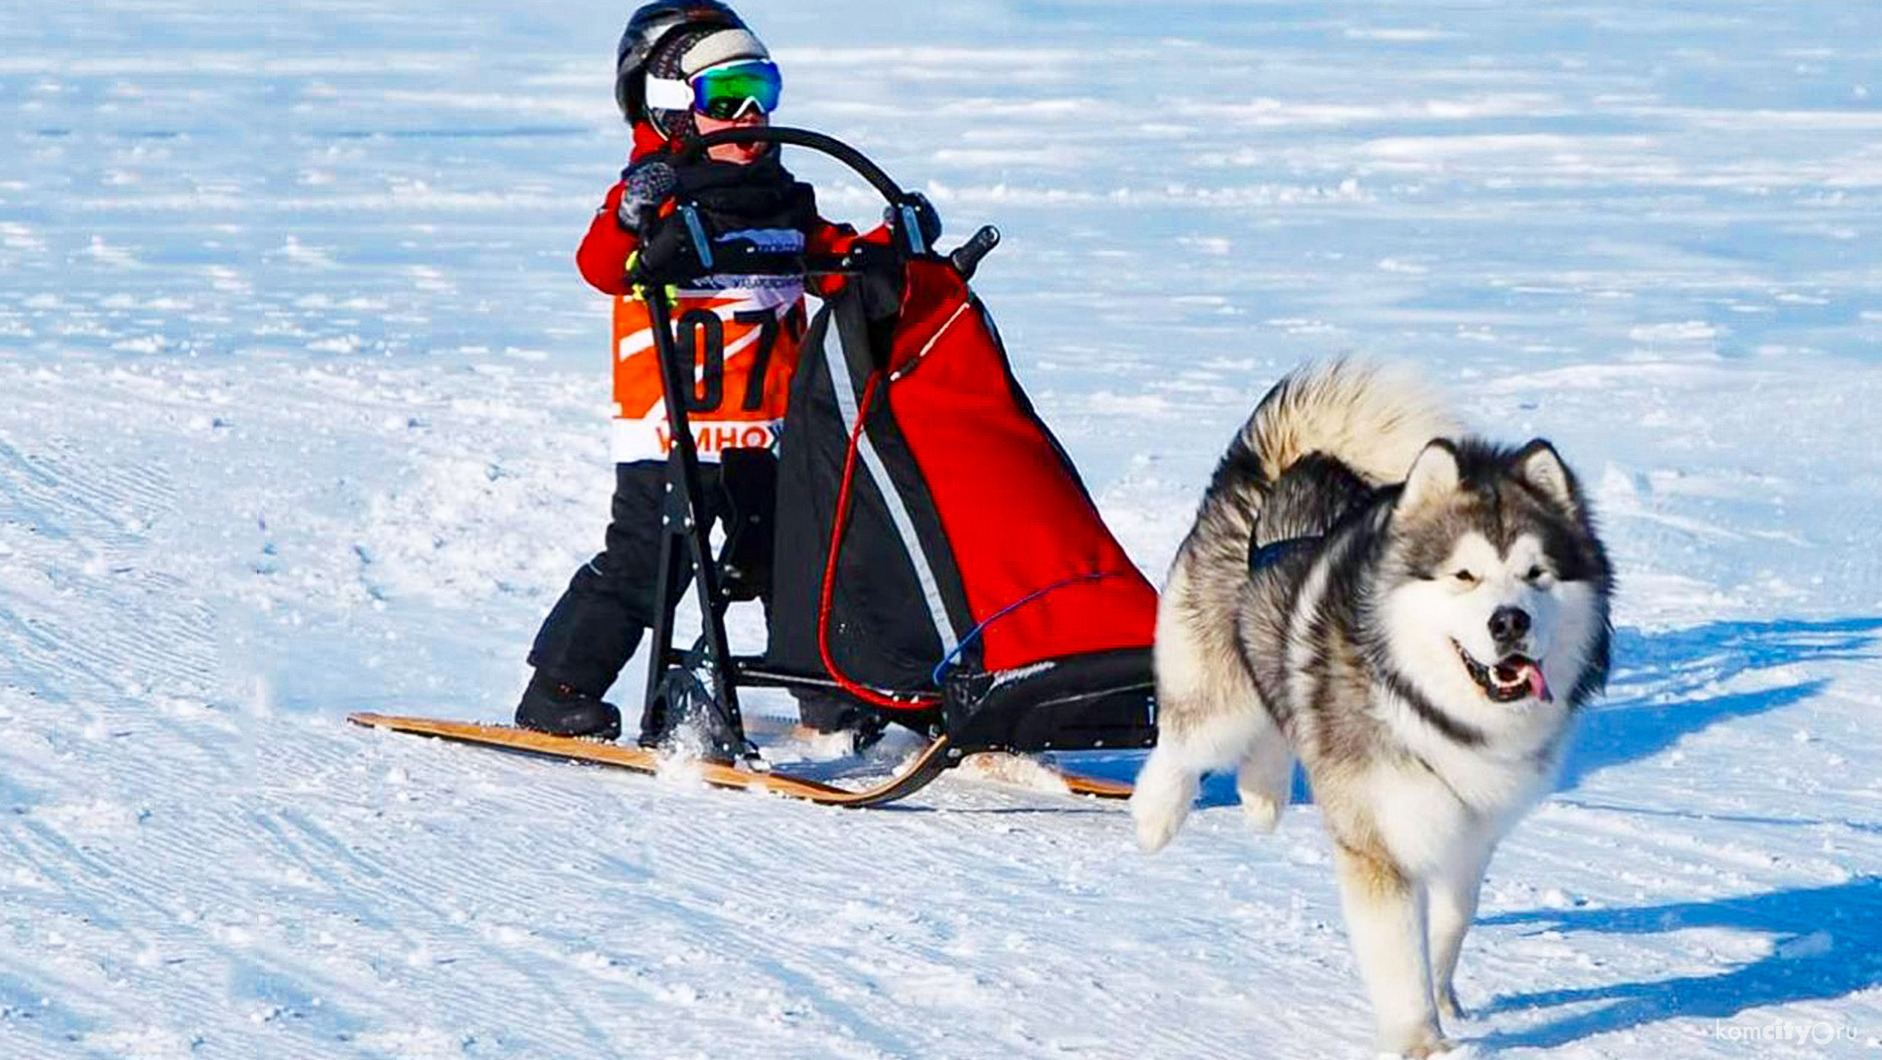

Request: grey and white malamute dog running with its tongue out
left=1131, top=361, right=1613, bottom=1058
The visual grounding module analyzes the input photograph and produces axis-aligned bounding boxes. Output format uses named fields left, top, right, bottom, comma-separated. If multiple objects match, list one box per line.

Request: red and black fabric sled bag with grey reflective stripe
left=766, top=258, right=1157, bottom=751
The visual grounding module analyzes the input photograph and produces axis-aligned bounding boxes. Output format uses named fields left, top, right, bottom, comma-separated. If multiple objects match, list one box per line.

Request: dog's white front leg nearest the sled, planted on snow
left=1334, top=843, right=1451, bottom=1060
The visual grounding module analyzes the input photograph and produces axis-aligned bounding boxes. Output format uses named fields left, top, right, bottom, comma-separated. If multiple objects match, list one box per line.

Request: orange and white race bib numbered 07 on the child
left=610, top=277, right=804, bottom=463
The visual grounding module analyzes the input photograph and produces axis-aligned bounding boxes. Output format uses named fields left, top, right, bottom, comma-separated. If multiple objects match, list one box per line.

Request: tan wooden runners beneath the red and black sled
left=346, top=714, right=1131, bottom=810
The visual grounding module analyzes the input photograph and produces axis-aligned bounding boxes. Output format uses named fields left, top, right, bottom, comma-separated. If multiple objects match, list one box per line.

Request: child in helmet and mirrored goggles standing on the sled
left=516, top=0, right=939, bottom=740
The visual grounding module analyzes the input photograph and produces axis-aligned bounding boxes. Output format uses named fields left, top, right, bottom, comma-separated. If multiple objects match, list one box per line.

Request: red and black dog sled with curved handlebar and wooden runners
left=352, top=128, right=1156, bottom=806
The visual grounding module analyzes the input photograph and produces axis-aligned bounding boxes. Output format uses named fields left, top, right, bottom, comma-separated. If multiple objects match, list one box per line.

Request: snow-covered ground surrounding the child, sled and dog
left=0, top=0, right=1882, bottom=1060
